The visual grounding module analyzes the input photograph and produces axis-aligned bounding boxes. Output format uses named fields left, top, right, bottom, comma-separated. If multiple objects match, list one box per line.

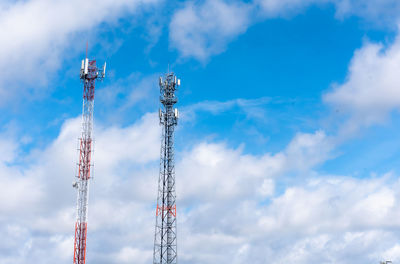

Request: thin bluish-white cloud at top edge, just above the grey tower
left=169, top=0, right=251, bottom=62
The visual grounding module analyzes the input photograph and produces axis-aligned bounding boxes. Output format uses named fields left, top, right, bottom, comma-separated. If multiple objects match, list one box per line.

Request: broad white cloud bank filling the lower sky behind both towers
left=0, top=110, right=400, bottom=264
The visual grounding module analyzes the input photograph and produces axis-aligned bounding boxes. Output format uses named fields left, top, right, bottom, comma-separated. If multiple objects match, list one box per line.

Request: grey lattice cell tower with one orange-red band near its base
left=153, top=73, right=180, bottom=264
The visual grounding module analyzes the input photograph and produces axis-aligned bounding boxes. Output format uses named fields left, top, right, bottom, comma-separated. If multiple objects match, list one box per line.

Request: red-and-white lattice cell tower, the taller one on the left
left=72, top=58, right=106, bottom=264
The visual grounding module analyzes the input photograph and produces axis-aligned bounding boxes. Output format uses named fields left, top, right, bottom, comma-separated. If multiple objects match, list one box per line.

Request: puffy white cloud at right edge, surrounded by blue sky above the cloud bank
left=324, top=33, right=400, bottom=132
